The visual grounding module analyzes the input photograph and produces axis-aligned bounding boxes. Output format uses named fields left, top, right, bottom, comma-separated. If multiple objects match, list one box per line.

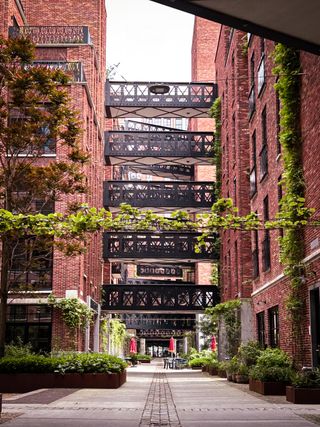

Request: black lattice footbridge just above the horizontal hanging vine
left=103, top=181, right=215, bottom=210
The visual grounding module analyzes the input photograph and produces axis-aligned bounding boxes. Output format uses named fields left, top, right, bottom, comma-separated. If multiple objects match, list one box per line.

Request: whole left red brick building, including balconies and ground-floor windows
left=0, top=0, right=106, bottom=350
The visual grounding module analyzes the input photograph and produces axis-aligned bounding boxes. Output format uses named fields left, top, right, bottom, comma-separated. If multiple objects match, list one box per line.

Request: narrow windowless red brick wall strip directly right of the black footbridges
left=215, top=26, right=252, bottom=300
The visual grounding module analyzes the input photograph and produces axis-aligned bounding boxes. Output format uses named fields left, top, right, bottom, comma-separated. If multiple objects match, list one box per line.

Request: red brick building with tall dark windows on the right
left=194, top=15, right=320, bottom=365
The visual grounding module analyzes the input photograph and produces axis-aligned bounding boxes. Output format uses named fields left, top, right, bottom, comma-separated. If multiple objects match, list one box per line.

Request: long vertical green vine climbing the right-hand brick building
left=273, top=44, right=314, bottom=344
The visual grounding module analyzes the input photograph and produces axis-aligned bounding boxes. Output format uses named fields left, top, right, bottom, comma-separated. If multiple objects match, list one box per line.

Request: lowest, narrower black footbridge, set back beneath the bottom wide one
left=120, top=313, right=195, bottom=332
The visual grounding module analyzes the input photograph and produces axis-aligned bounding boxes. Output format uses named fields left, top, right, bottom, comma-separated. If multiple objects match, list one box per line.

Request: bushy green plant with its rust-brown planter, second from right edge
left=249, top=348, right=293, bottom=395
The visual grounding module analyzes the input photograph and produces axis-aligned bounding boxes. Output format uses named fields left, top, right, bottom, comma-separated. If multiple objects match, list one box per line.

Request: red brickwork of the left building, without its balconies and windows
left=0, top=0, right=106, bottom=351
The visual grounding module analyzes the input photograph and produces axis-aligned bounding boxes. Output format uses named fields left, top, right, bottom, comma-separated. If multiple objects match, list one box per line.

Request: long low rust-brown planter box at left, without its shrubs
left=0, top=370, right=127, bottom=393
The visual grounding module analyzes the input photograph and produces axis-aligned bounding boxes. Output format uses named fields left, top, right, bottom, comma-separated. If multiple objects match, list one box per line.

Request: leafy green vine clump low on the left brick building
left=48, top=294, right=94, bottom=330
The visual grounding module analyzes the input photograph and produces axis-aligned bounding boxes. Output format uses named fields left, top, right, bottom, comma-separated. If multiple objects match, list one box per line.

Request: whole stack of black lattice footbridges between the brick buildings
left=102, top=81, right=219, bottom=344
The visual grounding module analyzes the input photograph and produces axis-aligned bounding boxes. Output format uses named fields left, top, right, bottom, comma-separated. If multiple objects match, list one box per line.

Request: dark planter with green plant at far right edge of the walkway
left=286, top=369, right=320, bottom=404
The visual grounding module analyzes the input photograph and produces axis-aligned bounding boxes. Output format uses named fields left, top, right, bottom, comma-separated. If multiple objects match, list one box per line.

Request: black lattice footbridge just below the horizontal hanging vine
left=103, top=231, right=219, bottom=262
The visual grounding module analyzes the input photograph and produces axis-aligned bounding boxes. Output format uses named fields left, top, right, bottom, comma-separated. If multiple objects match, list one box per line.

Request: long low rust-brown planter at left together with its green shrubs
left=0, top=353, right=127, bottom=393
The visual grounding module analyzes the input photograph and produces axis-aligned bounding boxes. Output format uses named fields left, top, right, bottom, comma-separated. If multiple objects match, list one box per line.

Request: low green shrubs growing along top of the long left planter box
left=0, top=353, right=127, bottom=374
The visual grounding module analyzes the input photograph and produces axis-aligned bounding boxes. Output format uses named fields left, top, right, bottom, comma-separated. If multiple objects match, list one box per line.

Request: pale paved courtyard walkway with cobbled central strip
left=3, top=359, right=320, bottom=427
